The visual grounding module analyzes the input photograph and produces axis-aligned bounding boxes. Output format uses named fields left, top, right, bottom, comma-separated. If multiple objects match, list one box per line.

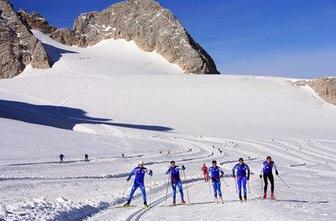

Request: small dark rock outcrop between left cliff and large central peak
left=18, top=9, right=57, bottom=34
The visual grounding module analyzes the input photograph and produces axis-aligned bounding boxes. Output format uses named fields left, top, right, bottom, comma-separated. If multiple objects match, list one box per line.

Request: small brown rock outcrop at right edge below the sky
left=308, top=78, right=336, bottom=105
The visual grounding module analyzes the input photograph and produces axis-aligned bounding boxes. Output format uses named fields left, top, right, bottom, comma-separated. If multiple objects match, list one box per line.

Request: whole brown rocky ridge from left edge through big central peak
left=0, top=0, right=219, bottom=78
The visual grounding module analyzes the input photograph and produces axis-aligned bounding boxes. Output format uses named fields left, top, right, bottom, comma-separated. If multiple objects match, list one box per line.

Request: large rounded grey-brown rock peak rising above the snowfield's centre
left=51, top=0, right=219, bottom=74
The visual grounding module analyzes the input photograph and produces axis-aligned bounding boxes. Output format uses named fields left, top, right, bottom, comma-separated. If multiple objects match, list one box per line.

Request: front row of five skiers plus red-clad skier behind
left=124, top=156, right=279, bottom=207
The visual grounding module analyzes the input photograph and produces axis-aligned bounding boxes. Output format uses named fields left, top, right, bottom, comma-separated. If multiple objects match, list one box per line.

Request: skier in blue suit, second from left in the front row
left=166, top=161, right=185, bottom=206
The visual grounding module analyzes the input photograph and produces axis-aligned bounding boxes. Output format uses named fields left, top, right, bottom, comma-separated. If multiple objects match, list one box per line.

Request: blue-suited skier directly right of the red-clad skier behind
left=209, top=160, right=224, bottom=203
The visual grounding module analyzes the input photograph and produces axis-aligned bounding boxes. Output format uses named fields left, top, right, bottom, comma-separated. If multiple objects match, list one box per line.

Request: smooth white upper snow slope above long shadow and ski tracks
left=0, top=32, right=336, bottom=138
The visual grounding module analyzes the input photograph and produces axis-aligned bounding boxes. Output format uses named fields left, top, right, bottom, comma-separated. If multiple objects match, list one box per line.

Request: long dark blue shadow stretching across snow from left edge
left=0, top=99, right=172, bottom=131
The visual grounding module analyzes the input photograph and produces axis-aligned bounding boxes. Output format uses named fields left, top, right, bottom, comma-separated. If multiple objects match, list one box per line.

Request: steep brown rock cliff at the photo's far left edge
left=0, top=0, right=51, bottom=78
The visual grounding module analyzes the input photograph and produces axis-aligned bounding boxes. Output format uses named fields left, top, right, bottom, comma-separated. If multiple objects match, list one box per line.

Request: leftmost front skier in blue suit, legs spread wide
left=124, top=161, right=153, bottom=207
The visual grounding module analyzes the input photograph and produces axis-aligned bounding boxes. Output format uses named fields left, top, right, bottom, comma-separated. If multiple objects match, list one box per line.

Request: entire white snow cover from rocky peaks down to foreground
left=0, top=31, right=336, bottom=221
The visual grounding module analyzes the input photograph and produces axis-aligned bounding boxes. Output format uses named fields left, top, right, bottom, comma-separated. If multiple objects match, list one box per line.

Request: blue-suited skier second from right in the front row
left=232, top=158, right=250, bottom=201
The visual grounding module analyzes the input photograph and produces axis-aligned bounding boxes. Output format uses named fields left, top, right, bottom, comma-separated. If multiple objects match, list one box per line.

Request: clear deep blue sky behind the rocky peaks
left=11, top=0, right=336, bottom=78
